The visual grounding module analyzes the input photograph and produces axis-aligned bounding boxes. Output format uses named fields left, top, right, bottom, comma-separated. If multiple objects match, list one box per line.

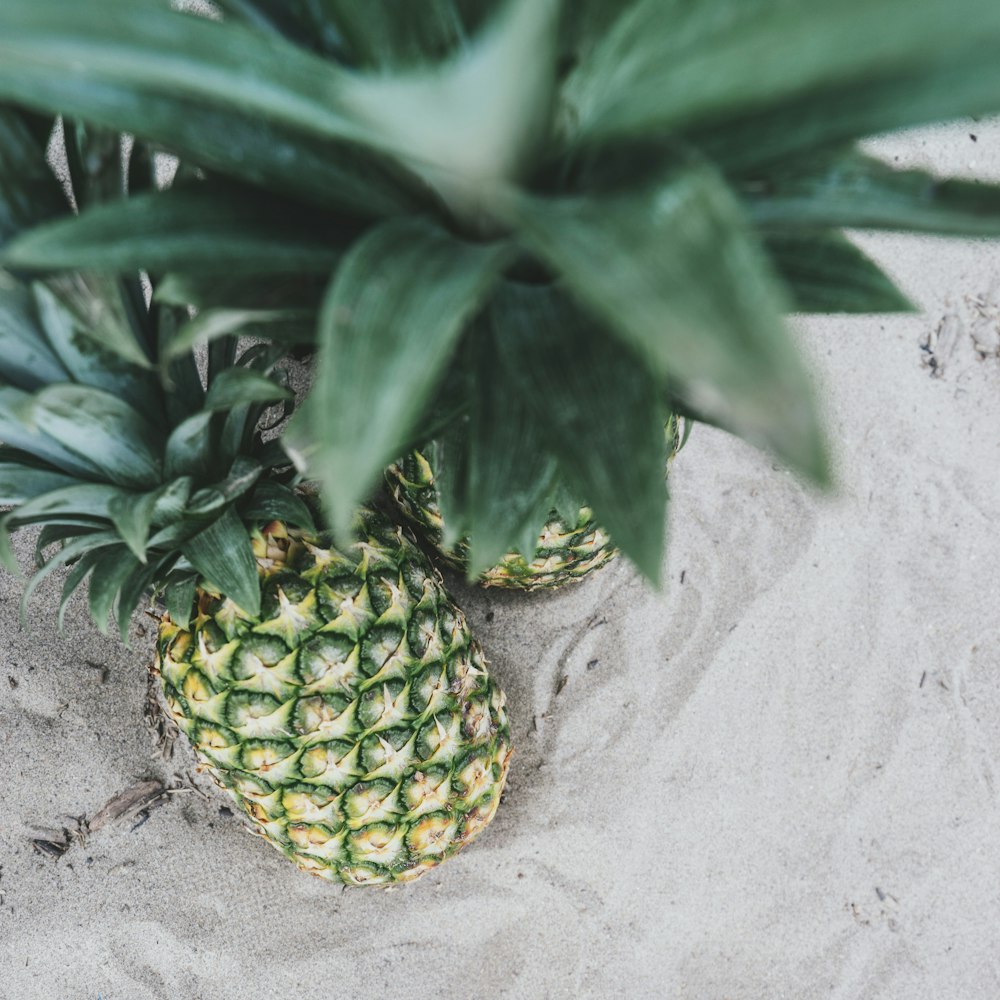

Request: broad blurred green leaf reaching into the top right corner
left=568, top=0, right=1000, bottom=148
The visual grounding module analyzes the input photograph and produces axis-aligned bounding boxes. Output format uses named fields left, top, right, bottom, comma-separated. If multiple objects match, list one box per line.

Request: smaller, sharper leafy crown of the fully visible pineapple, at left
left=0, top=109, right=312, bottom=637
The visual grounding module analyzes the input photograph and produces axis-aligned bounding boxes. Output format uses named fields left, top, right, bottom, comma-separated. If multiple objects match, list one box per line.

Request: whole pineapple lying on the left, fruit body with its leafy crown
left=0, top=108, right=511, bottom=885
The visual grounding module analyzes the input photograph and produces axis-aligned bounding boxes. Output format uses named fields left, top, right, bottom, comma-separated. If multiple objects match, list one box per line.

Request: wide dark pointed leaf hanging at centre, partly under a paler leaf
left=490, top=284, right=667, bottom=584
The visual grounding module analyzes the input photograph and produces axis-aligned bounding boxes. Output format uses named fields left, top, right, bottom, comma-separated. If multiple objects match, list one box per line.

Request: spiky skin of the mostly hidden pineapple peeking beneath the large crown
left=386, top=451, right=618, bottom=591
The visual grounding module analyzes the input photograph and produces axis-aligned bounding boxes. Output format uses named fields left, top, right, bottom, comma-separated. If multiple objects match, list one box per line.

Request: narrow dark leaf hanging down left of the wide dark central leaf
left=466, top=328, right=556, bottom=580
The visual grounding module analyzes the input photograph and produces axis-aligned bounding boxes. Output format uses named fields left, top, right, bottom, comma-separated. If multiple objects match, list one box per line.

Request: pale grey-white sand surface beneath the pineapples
left=0, top=123, right=1000, bottom=1000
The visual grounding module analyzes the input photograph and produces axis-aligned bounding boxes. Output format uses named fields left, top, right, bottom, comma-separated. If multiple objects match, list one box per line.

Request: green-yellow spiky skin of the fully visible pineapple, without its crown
left=157, top=512, right=511, bottom=885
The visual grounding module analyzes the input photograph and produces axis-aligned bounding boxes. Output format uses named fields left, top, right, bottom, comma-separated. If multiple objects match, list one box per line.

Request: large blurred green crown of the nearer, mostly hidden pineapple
left=0, top=0, right=1000, bottom=579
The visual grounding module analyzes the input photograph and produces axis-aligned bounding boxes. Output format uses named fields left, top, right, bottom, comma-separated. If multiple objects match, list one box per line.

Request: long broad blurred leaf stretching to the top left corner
left=0, top=0, right=419, bottom=217
